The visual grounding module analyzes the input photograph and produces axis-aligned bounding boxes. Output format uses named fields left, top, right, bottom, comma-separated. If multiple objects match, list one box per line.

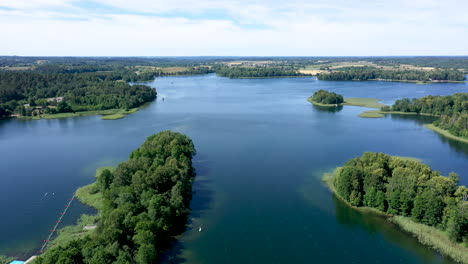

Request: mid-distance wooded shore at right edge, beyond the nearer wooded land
left=382, top=93, right=468, bottom=138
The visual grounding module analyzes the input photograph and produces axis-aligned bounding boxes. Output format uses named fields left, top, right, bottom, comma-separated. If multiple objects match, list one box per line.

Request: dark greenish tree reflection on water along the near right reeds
left=333, top=195, right=455, bottom=264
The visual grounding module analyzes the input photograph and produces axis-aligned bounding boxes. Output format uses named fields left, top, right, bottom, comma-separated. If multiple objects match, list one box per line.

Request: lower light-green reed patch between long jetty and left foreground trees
left=49, top=215, right=98, bottom=248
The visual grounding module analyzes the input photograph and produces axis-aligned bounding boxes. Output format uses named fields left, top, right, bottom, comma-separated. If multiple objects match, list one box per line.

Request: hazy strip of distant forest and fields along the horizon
left=0, top=56, right=468, bottom=70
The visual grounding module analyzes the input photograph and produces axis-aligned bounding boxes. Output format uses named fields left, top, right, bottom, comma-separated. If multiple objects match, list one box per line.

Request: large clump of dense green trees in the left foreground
left=35, top=131, right=195, bottom=264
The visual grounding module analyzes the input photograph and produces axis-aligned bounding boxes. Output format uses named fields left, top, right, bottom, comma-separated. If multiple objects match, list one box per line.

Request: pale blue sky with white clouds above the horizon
left=0, top=0, right=468, bottom=56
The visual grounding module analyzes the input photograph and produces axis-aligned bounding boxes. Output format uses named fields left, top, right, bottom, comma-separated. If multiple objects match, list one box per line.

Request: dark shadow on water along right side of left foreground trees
left=161, top=158, right=214, bottom=263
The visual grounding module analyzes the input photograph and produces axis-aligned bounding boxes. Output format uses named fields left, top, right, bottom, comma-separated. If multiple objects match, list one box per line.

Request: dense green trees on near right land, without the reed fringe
left=333, top=152, right=468, bottom=243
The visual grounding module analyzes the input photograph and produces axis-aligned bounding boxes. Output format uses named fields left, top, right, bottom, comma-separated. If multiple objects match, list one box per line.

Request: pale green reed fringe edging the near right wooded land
left=322, top=167, right=468, bottom=263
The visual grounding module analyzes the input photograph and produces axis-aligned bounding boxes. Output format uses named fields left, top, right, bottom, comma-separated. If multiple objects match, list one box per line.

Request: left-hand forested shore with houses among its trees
left=0, top=71, right=156, bottom=117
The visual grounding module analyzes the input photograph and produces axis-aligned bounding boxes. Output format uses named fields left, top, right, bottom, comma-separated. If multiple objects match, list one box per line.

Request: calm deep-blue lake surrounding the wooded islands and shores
left=0, top=75, right=468, bottom=263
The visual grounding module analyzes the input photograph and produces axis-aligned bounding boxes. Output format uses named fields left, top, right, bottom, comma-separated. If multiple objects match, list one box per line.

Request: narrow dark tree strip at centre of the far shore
left=216, top=67, right=308, bottom=78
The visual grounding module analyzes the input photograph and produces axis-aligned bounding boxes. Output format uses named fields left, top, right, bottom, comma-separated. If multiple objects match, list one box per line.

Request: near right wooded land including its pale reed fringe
left=323, top=152, right=468, bottom=263
